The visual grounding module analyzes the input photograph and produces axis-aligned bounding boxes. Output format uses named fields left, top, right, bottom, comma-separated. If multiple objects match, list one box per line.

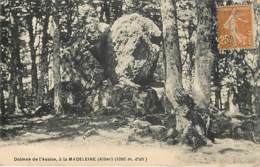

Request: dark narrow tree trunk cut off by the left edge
left=0, top=3, right=5, bottom=117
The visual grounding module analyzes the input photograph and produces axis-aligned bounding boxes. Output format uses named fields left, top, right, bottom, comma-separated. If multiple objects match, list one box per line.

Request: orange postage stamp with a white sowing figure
left=217, top=5, right=255, bottom=50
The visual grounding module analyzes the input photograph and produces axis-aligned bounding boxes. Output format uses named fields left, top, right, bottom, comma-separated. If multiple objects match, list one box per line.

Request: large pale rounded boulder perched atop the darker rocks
left=111, top=14, right=161, bottom=85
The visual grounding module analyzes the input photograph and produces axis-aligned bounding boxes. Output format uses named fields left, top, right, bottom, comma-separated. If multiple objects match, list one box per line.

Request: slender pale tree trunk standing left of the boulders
left=53, top=0, right=62, bottom=114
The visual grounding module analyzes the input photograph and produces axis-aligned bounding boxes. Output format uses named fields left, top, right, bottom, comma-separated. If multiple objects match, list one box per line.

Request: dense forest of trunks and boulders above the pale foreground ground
left=0, top=0, right=260, bottom=151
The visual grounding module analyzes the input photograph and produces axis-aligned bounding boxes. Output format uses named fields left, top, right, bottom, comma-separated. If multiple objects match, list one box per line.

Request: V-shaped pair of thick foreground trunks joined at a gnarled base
left=161, top=0, right=221, bottom=148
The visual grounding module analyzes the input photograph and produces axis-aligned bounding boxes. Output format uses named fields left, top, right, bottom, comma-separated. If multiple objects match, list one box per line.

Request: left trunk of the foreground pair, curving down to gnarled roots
left=161, top=0, right=209, bottom=149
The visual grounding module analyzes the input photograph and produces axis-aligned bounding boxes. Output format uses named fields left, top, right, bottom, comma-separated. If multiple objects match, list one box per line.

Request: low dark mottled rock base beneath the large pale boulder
left=88, top=81, right=164, bottom=116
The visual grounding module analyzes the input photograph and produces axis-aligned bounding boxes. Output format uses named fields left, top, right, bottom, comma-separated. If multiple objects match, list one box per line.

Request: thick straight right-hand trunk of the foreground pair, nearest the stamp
left=193, top=0, right=215, bottom=109
